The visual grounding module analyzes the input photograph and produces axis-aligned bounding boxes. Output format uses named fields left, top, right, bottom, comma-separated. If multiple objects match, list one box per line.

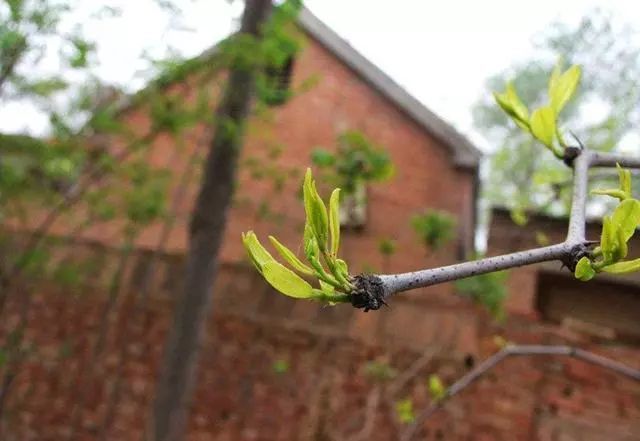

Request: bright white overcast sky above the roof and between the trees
left=0, top=0, right=640, bottom=147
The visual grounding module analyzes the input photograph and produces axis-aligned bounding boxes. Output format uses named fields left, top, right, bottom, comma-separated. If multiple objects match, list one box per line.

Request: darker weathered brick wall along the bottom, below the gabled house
left=2, top=232, right=640, bottom=440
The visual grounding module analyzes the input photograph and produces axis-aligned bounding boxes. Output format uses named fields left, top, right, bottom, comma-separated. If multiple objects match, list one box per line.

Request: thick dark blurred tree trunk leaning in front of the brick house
left=151, top=0, right=271, bottom=441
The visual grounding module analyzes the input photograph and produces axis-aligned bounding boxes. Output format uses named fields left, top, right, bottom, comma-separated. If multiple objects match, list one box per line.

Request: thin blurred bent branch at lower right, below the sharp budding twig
left=401, top=345, right=640, bottom=441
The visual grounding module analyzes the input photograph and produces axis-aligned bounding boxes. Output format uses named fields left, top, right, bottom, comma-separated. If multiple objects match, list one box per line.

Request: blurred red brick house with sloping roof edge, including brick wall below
left=3, top=6, right=640, bottom=440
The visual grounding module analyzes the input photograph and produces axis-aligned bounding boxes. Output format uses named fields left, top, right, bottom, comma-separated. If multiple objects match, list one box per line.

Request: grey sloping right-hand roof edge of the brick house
left=298, top=8, right=482, bottom=168
